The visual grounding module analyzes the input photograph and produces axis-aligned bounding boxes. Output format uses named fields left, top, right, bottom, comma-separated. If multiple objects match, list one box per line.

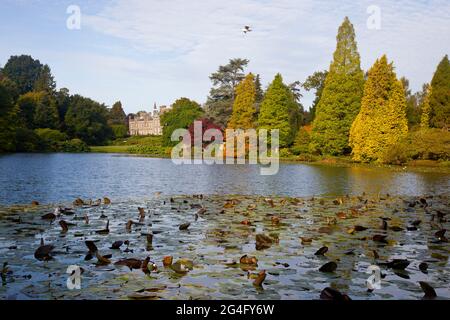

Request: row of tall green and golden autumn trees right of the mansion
left=180, top=18, right=450, bottom=164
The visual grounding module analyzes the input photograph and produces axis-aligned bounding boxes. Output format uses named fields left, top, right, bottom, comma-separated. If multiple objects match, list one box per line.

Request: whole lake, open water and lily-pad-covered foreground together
left=0, top=154, right=450, bottom=300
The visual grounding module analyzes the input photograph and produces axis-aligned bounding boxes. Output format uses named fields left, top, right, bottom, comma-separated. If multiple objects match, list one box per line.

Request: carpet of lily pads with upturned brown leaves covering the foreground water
left=0, top=195, right=450, bottom=300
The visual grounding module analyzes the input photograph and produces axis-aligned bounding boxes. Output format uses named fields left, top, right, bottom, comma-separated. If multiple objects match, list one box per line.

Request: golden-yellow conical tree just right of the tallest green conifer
left=350, top=56, right=408, bottom=162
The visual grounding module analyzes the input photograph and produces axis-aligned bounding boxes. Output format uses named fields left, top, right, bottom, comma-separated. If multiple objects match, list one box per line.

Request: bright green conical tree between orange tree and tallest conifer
left=258, top=74, right=300, bottom=147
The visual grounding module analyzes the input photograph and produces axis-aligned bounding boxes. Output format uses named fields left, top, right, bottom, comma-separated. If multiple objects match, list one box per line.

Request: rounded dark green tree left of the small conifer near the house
left=65, top=95, right=113, bottom=145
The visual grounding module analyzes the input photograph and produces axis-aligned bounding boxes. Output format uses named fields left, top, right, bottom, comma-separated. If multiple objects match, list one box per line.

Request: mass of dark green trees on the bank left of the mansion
left=0, top=55, right=128, bottom=152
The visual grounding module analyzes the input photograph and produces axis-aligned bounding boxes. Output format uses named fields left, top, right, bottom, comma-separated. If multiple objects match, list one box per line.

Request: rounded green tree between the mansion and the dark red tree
left=161, top=98, right=204, bottom=146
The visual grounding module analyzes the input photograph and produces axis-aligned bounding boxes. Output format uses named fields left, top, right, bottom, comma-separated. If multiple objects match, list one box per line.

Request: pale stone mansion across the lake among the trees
left=128, top=104, right=167, bottom=136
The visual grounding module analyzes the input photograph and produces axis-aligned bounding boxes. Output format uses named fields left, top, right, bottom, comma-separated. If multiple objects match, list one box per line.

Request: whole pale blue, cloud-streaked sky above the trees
left=0, top=0, right=450, bottom=113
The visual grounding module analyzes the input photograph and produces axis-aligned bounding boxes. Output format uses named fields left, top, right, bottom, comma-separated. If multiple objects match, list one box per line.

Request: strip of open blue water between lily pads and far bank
left=0, top=154, right=450, bottom=205
